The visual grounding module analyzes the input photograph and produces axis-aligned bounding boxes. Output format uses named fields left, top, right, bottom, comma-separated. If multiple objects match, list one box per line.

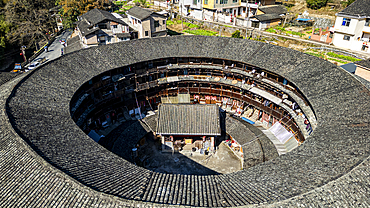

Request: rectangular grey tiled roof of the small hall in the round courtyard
left=156, top=104, right=221, bottom=136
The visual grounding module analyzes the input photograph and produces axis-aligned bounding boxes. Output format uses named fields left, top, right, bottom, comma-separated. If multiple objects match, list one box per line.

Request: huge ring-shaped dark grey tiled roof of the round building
left=0, top=36, right=370, bottom=207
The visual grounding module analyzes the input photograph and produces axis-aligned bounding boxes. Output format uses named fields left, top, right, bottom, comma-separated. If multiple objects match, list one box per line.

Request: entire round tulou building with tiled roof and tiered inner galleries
left=0, top=36, right=370, bottom=207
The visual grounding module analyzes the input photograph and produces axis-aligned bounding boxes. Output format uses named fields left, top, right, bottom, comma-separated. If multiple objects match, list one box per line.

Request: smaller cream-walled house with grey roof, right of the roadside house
left=125, top=6, right=167, bottom=38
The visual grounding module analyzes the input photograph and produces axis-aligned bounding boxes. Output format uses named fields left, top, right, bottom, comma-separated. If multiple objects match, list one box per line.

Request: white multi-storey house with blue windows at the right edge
left=333, top=0, right=370, bottom=53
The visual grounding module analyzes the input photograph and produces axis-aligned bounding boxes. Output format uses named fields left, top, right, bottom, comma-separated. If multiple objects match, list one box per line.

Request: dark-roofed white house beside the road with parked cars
left=75, top=9, right=131, bottom=48
